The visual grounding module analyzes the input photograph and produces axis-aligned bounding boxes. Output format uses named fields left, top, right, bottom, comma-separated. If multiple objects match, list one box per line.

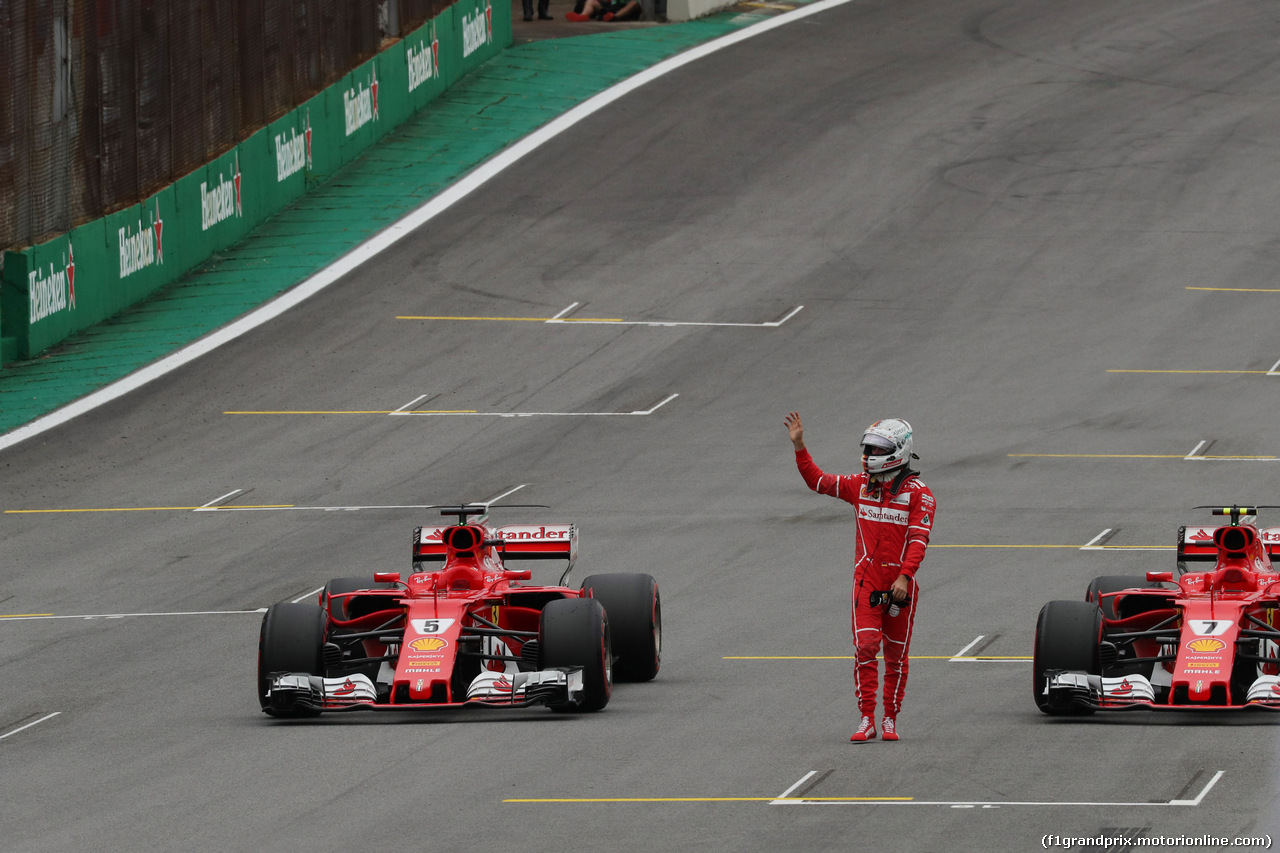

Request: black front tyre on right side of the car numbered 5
left=538, top=598, right=613, bottom=711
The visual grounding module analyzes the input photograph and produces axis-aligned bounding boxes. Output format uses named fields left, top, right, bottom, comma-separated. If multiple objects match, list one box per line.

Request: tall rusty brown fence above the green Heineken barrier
left=0, top=0, right=451, bottom=248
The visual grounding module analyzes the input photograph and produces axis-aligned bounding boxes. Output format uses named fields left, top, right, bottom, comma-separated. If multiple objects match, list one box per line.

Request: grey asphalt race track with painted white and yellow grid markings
left=0, top=0, right=1280, bottom=853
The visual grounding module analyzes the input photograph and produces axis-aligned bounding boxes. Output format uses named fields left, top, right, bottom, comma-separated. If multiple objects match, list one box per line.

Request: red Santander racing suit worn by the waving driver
left=796, top=450, right=937, bottom=717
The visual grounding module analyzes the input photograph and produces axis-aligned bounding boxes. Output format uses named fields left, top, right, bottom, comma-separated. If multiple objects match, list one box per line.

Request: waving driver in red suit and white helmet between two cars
left=786, top=411, right=937, bottom=743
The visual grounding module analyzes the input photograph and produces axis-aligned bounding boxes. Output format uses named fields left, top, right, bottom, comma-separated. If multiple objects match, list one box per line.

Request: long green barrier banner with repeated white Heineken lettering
left=0, top=0, right=512, bottom=361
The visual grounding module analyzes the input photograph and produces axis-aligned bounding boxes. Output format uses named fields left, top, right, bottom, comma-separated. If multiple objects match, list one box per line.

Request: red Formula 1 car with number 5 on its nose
left=257, top=506, right=662, bottom=717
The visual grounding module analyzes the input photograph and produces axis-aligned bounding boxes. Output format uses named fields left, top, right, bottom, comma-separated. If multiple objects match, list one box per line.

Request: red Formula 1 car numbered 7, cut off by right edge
left=1034, top=506, right=1280, bottom=715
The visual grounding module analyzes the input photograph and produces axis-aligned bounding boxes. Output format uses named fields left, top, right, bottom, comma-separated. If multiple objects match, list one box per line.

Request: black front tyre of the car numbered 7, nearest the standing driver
left=1032, top=601, right=1102, bottom=716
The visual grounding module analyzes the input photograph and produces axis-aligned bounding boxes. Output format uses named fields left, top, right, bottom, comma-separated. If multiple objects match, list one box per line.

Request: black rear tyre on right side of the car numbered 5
left=582, top=574, right=662, bottom=681
